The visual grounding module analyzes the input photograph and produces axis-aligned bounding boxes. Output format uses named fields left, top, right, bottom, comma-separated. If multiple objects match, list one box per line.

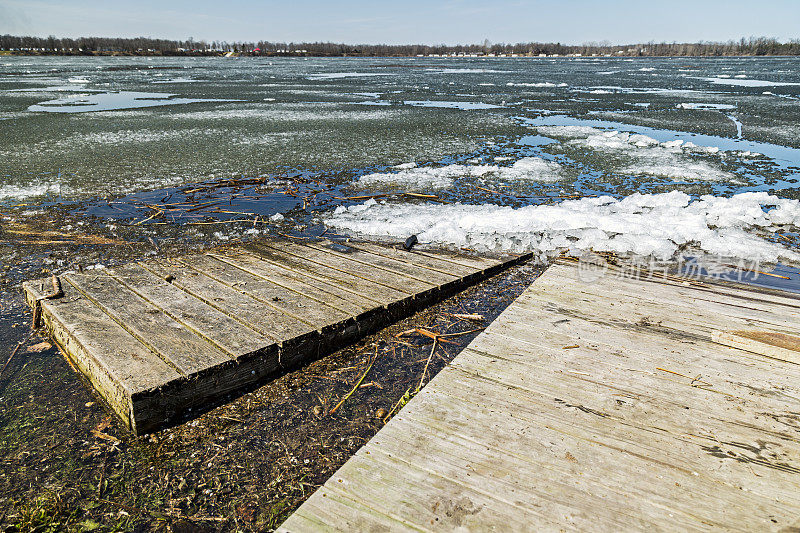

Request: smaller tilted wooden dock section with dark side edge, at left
left=23, top=242, right=527, bottom=434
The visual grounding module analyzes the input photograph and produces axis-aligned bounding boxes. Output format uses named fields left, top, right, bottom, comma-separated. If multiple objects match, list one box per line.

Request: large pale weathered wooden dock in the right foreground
left=279, top=264, right=800, bottom=532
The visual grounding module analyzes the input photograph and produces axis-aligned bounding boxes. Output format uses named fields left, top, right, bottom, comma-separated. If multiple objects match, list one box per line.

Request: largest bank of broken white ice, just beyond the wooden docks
left=323, top=191, right=800, bottom=262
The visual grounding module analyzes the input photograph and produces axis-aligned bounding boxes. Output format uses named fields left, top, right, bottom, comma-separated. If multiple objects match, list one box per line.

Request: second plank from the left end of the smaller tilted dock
left=62, top=270, right=234, bottom=375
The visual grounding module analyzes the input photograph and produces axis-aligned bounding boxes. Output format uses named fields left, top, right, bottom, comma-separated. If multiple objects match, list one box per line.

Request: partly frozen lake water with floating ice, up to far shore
left=0, top=57, right=800, bottom=270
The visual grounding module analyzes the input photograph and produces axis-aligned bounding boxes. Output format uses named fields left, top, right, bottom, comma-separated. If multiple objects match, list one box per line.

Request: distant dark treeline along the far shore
left=0, top=35, right=800, bottom=57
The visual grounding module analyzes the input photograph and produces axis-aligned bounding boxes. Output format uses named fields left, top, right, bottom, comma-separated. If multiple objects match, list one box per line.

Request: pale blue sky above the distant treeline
left=0, top=0, right=800, bottom=44
